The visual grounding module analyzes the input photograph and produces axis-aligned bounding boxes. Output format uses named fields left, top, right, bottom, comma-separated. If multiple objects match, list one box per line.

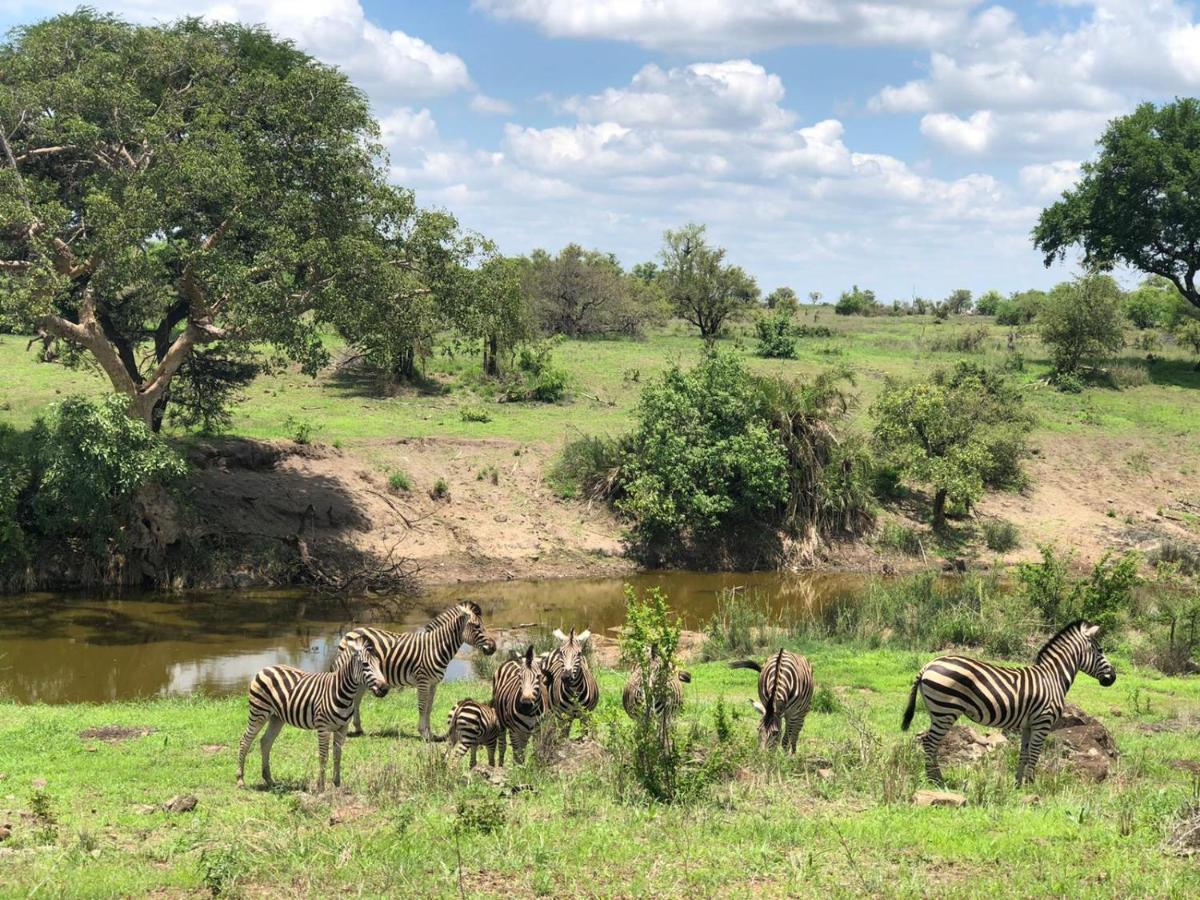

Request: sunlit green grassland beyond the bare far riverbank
left=0, top=308, right=1200, bottom=448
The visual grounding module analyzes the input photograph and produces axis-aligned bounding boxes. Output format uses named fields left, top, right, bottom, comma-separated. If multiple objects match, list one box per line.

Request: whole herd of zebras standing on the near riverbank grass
left=238, top=601, right=1116, bottom=791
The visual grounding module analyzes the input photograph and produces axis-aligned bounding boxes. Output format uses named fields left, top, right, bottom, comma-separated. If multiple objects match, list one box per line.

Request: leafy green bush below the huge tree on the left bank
left=30, top=396, right=187, bottom=559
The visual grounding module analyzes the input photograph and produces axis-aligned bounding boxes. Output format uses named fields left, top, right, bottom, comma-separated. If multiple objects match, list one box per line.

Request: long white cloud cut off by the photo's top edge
left=475, top=0, right=980, bottom=52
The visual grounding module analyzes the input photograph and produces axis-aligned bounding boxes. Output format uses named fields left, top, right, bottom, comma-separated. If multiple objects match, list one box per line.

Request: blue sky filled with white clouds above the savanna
left=0, top=0, right=1200, bottom=300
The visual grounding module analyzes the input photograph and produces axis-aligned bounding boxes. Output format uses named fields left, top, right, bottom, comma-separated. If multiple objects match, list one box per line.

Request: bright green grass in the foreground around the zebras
left=0, top=644, right=1200, bottom=896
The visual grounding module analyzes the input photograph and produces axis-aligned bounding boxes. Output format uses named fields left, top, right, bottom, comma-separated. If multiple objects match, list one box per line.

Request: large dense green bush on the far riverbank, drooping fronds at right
left=618, top=352, right=871, bottom=564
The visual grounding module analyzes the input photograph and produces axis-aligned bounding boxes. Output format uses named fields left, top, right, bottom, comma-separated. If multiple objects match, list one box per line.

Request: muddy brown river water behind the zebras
left=0, top=571, right=863, bottom=703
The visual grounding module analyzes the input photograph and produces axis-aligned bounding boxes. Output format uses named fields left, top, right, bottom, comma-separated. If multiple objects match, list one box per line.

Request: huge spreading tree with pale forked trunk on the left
left=0, top=10, right=403, bottom=427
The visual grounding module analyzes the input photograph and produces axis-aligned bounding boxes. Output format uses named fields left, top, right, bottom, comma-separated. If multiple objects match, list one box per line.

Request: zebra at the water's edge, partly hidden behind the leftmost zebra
left=334, top=600, right=496, bottom=740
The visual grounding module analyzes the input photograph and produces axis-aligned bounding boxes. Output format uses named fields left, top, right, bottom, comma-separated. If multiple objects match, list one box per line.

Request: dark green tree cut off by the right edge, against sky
left=1033, top=97, right=1200, bottom=308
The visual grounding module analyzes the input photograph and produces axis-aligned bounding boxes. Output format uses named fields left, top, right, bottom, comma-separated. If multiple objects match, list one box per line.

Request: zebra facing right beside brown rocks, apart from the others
left=900, top=620, right=1117, bottom=785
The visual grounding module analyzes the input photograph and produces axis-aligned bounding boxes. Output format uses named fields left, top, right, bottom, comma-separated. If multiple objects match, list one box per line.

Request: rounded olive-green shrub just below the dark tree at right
left=1038, top=275, right=1124, bottom=374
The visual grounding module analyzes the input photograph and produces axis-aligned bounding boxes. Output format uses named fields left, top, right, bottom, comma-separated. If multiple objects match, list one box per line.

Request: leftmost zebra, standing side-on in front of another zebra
left=238, top=640, right=388, bottom=792
